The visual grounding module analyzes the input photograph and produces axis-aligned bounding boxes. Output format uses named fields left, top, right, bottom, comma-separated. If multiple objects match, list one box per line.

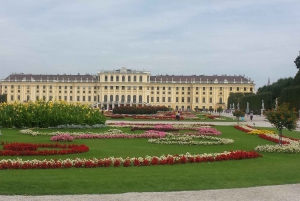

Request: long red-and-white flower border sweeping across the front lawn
left=0, top=150, right=262, bottom=170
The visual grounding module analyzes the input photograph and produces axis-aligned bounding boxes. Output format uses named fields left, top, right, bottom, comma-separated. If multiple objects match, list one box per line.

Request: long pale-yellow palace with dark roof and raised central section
left=0, top=67, right=255, bottom=110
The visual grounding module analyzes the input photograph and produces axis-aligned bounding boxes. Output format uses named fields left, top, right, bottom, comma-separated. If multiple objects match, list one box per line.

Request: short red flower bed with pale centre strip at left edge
left=0, top=142, right=89, bottom=156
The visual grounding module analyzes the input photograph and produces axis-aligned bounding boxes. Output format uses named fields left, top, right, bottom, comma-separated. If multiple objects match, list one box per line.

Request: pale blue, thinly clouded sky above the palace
left=0, top=0, right=300, bottom=90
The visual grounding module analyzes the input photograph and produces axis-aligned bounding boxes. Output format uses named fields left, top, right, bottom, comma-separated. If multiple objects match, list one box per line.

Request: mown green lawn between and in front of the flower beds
left=0, top=126, right=300, bottom=195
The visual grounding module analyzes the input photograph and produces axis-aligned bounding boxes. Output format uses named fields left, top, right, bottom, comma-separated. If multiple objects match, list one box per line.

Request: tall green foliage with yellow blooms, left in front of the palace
left=0, top=100, right=106, bottom=128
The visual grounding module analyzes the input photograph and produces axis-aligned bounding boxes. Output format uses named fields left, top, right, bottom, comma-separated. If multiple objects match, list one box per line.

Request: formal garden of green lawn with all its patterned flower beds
left=0, top=103, right=300, bottom=195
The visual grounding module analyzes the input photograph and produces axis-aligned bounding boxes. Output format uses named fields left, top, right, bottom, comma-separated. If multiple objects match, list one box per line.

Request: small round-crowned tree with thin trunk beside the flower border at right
left=266, top=103, right=298, bottom=146
